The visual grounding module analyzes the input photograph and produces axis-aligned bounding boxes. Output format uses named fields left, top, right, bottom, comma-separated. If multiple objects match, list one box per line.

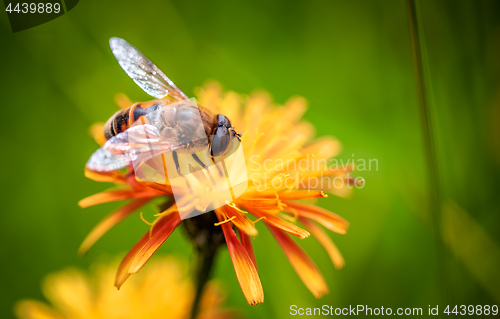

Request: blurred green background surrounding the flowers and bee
left=0, top=0, right=500, bottom=318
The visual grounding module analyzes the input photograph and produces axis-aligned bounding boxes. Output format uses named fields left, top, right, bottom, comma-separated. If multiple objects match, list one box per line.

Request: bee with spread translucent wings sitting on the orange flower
left=86, top=38, right=241, bottom=175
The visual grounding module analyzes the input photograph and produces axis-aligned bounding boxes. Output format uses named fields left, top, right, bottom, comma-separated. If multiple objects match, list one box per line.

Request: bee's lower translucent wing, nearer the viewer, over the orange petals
left=86, top=124, right=186, bottom=172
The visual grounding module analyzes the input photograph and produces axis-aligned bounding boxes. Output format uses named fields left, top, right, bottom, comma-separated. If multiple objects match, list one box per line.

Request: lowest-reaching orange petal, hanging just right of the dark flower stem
left=218, top=216, right=264, bottom=305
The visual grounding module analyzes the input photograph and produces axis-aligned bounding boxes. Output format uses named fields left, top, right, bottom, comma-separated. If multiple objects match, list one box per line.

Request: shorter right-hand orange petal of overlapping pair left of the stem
left=128, top=212, right=182, bottom=274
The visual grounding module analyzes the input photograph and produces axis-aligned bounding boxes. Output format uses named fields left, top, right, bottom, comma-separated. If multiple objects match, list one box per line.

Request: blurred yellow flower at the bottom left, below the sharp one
left=14, top=257, right=235, bottom=319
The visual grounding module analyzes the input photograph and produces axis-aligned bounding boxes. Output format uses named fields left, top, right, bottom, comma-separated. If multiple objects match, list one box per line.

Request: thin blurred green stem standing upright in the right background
left=407, top=0, right=449, bottom=301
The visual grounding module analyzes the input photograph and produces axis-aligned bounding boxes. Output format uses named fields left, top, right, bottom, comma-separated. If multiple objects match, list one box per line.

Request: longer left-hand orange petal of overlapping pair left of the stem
left=115, top=212, right=180, bottom=289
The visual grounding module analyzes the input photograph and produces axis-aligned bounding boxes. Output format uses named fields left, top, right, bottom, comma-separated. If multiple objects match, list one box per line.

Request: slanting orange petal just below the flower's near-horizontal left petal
left=78, top=198, right=150, bottom=255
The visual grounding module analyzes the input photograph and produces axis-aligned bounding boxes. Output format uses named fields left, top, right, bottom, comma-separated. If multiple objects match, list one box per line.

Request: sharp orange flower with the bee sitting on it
left=80, top=83, right=362, bottom=304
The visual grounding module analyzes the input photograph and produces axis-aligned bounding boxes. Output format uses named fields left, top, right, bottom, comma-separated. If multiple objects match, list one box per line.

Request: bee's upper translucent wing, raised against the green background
left=109, top=38, right=188, bottom=100
